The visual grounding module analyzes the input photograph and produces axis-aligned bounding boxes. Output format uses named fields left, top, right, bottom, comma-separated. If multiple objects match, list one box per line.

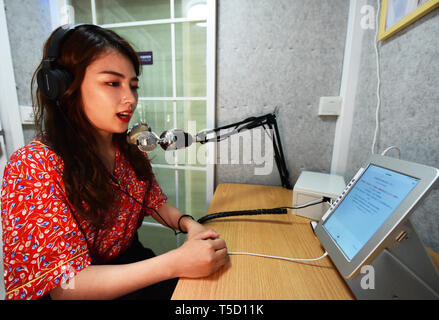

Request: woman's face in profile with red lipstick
left=81, top=50, right=139, bottom=137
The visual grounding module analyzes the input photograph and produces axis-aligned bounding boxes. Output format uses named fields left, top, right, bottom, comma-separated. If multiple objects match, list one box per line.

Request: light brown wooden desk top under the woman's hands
left=172, top=184, right=355, bottom=300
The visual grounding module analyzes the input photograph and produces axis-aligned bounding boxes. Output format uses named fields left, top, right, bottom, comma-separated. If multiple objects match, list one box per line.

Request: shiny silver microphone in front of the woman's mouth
left=127, top=123, right=193, bottom=152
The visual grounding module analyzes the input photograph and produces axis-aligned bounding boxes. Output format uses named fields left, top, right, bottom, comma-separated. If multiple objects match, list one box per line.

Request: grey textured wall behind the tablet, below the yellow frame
left=346, top=1, right=439, bottom=252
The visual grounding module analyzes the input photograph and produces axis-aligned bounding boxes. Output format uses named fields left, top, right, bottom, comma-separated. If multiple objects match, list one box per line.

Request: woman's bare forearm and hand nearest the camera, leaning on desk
left=50, top=230, right=228, bottom=299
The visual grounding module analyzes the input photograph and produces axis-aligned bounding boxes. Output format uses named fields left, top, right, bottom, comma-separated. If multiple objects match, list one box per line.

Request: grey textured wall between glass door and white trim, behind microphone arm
left=215, top=0, right=349, bottom=185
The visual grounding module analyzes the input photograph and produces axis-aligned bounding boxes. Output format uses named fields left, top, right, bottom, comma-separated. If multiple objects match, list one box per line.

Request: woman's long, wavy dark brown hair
left=31, top=25, right=152, bottom=228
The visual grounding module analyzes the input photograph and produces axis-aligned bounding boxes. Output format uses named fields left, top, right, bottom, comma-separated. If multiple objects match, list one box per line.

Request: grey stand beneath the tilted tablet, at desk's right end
left=345, top=220, right=439, bottom=300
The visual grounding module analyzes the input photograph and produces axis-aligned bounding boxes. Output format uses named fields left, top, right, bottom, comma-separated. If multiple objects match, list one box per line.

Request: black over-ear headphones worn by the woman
left=37, top=23, right=89, bottom=101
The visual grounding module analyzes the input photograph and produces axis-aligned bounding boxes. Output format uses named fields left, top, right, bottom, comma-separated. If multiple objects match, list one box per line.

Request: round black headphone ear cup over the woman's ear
left=37, top=68, right=73, bottom=100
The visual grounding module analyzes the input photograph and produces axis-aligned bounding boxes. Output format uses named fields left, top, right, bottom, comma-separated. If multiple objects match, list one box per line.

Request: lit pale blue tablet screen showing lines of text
left=323, top=165, right=419, bottom=261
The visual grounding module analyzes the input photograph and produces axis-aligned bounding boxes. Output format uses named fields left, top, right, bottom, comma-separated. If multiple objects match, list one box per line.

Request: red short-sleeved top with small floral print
left=1, top=140, right=167, bottom=300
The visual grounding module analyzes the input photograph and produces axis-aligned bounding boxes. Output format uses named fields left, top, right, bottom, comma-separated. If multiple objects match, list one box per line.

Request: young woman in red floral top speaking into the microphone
left=1, top=25, right=228, bottom=299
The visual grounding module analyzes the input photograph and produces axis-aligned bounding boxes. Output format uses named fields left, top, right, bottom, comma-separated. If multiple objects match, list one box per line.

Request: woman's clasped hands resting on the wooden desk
left=174, top=229, right=229, bottom=278
